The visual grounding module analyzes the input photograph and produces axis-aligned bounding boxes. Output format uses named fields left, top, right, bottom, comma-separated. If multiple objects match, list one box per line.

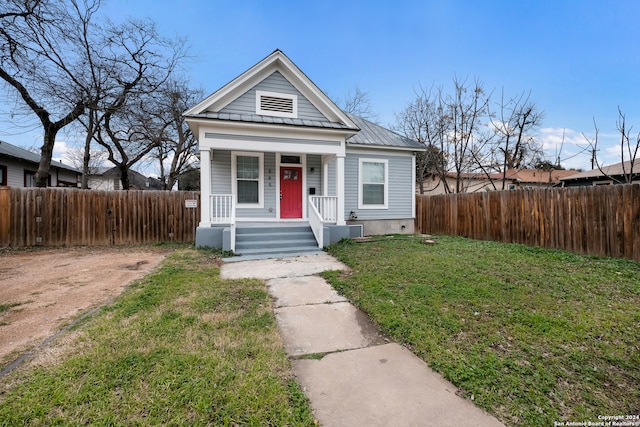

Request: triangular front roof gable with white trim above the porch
left=184, top=50, right=357, bottom=129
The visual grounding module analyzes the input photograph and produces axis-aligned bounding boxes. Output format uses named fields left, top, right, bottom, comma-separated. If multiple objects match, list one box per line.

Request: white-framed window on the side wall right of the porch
left=358, top=159, right=389, bottom=209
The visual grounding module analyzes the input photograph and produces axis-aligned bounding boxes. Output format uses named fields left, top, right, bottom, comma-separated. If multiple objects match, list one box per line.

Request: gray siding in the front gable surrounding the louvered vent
left=220, top=71, right=328, bottom=122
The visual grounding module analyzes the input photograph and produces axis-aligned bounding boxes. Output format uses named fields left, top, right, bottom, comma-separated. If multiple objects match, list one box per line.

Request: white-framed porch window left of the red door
left=233, top=153, right=264, bottom=207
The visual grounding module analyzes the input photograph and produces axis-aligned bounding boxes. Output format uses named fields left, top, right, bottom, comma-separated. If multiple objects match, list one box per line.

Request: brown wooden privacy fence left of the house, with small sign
left=0, top=187, right=200, bottom=247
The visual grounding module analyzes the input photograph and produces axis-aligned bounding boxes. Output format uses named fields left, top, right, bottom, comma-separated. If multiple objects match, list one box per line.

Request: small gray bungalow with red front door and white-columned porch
left=184, top=50, right=423, bottom=254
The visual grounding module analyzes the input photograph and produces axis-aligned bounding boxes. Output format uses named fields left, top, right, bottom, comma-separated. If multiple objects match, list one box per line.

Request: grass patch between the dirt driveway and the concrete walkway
left=0, top=248, right=314, bottom=426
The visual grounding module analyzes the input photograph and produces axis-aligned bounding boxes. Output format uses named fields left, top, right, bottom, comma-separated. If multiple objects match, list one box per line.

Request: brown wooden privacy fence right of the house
left=416, top=184, right=640, bottom=261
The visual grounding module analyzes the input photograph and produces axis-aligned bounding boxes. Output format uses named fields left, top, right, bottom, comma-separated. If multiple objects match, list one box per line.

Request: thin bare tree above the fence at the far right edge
left=582, top=107, right=640, bottom=184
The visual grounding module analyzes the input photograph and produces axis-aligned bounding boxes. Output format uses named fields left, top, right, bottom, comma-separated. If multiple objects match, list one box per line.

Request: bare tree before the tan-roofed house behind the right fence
left=489, top=91, right=544, bottom=190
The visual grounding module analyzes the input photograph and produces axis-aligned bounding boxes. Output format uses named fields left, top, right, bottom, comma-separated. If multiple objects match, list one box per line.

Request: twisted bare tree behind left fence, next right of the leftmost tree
left=87, top=20, right=184, bottom=189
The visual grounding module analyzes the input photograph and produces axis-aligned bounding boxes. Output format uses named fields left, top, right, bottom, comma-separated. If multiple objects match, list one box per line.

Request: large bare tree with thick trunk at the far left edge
left=0, top=0, right=94, bottom=187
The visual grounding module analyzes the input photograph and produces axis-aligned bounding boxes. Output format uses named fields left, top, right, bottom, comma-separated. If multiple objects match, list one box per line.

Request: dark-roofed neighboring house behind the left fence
left=0, top=141, right=82, bottom=187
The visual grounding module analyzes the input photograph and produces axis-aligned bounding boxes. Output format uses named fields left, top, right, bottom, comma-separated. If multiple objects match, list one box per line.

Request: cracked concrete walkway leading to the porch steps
left=220, top=254, right=503, bottom=427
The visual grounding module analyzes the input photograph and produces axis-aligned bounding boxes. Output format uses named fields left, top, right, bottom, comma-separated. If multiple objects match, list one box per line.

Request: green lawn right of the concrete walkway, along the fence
left=325, top=237, right=640, bottom=426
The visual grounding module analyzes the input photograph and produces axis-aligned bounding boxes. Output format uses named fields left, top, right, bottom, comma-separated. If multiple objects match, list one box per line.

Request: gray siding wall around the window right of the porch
left=345, top=153, right=414, bottom=220
